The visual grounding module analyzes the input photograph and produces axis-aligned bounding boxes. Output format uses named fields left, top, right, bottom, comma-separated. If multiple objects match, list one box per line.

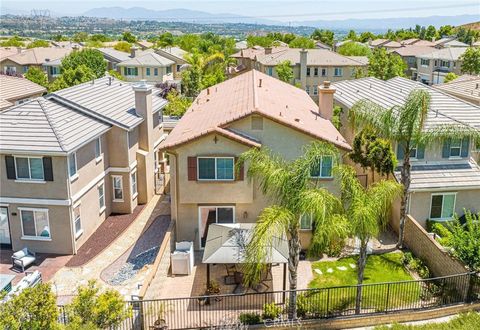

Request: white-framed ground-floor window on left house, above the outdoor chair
left=19, top=208, right=51, bottom=239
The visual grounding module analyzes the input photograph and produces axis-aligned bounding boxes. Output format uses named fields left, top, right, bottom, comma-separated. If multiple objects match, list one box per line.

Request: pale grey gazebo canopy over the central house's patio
left=203, top=223, right=288, bottom=264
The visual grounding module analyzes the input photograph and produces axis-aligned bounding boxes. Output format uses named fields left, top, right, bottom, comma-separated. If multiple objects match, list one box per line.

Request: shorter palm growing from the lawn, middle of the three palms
left=334, top=166, right=402, bottom=314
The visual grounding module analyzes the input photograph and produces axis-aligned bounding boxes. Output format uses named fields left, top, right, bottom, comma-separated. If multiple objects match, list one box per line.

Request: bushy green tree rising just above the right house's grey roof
left=368, top=48, right=407, bottom=80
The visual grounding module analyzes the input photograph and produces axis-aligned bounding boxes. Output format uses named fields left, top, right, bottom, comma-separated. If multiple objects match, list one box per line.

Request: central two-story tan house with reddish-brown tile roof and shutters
left=160, top=70, right=350, bottom=249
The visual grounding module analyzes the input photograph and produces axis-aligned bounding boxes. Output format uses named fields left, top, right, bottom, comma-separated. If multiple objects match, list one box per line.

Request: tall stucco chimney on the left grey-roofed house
left=133, top=80, right=154, bottom=151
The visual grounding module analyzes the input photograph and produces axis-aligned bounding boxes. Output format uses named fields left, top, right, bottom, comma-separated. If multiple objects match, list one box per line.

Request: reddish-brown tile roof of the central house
left=160, top=70, right=350, bottom=150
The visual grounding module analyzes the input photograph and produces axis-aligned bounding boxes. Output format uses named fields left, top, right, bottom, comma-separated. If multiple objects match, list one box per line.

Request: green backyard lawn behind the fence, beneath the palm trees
left=300, top=252, right=421, bottom=315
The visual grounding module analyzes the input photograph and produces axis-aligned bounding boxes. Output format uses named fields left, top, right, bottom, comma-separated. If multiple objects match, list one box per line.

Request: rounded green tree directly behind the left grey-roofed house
left=62, top=48, right=107, bottom=78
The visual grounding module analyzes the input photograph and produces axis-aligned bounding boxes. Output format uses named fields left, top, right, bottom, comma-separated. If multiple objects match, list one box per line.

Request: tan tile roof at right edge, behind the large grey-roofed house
left=435, top=75, right=480, bottom=105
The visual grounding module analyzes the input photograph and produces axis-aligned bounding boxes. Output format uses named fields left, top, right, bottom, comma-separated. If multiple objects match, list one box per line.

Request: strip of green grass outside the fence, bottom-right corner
left=375, top=312, right=480, bottom=330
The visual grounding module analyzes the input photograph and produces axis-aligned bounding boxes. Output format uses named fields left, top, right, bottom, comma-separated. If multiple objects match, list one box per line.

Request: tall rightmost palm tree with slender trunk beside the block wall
left=349, top=89, right=480, bottom=248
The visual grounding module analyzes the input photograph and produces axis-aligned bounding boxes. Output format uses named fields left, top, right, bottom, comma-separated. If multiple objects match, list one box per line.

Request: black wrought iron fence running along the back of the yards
left=59, top=273, right=480, bottom=330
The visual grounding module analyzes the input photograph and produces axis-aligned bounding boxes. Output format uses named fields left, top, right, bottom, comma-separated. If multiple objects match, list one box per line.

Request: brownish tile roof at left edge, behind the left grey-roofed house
left=0, top=74, right=47, bottom=110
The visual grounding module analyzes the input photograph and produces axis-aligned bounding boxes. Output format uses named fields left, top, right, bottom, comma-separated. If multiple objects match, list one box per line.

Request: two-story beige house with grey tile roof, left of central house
left=0, top=77, right=166, bottom=254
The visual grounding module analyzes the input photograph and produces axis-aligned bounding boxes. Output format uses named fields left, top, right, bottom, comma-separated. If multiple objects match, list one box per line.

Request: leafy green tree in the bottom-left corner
left=0, top=283, right=58, bottom=330
